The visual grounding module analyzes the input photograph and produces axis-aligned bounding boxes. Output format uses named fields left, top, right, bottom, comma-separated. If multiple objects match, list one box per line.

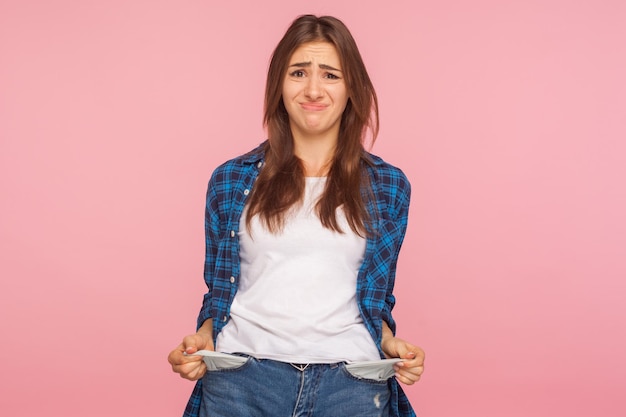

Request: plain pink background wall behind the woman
left=0, top=0, right=626, bottom=417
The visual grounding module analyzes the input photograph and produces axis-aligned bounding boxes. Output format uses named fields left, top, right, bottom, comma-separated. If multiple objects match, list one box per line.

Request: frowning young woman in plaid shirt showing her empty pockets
left=168, top=15, right=424, bottom=417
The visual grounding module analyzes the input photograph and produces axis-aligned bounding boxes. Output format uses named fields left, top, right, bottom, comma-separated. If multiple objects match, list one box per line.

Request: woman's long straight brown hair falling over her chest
left=246, top=15, right=378, bottom=236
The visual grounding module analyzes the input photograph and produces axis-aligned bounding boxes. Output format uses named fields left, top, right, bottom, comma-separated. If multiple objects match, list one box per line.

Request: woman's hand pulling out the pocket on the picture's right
left=381, top=321, right=425, bottom=385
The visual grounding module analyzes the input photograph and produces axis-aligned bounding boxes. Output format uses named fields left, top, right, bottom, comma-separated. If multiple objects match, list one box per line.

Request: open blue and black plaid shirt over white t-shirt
left=184, top=141, right=415, bottom=417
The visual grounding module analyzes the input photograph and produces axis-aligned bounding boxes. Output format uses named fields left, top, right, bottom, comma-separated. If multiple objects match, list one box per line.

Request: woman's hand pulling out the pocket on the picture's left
left=167, top=320, right=215, bottom=381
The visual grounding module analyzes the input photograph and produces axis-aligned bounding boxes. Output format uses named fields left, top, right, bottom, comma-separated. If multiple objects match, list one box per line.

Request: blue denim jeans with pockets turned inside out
left=200, top=357, right=390, bottom=417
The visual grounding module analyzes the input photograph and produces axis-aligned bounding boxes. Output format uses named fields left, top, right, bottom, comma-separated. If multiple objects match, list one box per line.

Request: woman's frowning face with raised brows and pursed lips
left=283, top=42, right=348, bottom=140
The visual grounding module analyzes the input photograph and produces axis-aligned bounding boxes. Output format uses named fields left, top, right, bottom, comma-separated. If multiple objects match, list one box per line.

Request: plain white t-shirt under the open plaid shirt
left=216, top=177, right=380, bottom=363
